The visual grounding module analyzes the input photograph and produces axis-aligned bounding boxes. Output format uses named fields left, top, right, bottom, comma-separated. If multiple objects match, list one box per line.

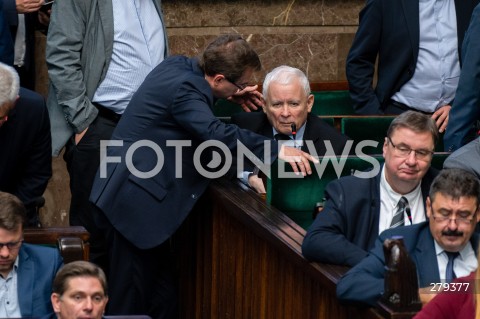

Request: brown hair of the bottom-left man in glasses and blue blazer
left=0, top=192, right=27, bottom=231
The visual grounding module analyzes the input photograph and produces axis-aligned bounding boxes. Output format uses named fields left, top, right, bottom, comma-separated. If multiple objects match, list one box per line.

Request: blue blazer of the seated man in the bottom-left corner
left=17, top=244, right=63, bottom=318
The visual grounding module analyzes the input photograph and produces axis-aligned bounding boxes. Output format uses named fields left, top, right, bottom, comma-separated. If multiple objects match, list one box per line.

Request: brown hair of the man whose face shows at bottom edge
left=52, top=260, right=108, bottom=296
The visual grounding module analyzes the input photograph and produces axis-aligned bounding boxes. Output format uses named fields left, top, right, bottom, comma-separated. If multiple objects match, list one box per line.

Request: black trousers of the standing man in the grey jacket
left=64, top=116, right=116, bottom=272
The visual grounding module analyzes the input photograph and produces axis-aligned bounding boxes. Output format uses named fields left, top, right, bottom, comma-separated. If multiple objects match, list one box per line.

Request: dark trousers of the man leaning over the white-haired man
left=94, top=207, right=178, bottom=319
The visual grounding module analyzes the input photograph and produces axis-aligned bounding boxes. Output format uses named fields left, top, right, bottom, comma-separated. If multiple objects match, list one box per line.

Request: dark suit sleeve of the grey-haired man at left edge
left=16, top=97, right=52, bottom=206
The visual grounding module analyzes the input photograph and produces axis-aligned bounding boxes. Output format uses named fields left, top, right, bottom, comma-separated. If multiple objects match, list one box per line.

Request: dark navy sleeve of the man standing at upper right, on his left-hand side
left=346, top=0, right=382, bottom=115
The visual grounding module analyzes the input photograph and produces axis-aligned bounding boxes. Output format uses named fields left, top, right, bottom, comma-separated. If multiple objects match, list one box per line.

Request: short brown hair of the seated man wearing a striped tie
left=387, top=111, right=438, bottom=145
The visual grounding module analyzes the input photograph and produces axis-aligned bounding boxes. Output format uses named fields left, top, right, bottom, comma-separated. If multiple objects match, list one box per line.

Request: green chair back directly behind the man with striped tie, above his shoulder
left=341, top=116, right=394, bottom=154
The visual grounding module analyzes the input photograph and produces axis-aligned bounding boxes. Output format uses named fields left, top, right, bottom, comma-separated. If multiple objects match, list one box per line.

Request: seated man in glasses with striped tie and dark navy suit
left=302, top=111, right=438, bottom=266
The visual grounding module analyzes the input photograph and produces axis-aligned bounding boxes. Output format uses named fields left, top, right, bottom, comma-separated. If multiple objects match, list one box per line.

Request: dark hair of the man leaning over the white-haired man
left=199, top=34, right=262, bottom=81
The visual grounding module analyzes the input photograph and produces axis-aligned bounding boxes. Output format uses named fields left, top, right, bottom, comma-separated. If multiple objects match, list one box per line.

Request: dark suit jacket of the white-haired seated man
left=232, top=112, right=350, bottom=156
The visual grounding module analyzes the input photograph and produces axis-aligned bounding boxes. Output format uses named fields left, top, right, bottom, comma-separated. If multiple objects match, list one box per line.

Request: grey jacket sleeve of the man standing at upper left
left=46, top=0, right=98, bottom=133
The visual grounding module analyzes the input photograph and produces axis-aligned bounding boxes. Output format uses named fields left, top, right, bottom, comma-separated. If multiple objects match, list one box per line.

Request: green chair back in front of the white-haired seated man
left=266, top=156, right=383, bottom=229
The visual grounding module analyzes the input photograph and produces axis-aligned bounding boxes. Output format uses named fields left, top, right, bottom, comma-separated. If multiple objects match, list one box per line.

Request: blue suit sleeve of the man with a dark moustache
left=337, top=236, right=385, bottom=306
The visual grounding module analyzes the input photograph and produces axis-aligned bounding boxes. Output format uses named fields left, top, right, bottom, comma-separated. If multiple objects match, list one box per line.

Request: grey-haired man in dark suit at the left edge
left=0, top=63, right=52, bottom=226
